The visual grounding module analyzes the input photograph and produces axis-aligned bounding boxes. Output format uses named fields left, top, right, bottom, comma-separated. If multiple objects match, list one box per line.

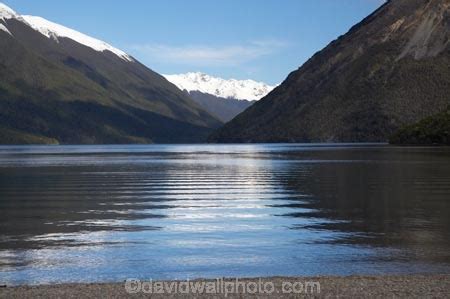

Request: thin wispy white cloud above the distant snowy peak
left=130, top=40, right=287, bottom=66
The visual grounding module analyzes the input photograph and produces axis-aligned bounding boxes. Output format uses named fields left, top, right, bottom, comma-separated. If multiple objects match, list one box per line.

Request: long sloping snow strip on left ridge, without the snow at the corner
left=22, top=16, right=133, bottom=61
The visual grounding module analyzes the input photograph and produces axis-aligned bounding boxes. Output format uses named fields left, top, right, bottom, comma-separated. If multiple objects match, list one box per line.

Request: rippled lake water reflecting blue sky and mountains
left=0, top=144, right=450, bottom=284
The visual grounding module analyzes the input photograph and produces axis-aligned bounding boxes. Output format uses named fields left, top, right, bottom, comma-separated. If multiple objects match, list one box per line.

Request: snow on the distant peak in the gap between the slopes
left=164, top=72, right=275, bottom=101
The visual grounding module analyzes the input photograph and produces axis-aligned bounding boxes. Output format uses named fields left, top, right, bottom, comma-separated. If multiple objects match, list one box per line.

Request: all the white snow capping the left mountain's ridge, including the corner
left=0, top=3, right=133, bottom=61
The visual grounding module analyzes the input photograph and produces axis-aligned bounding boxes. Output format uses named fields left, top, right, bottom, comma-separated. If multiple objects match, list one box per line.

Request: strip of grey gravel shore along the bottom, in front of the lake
left=0, top=274, right=450, bottom=298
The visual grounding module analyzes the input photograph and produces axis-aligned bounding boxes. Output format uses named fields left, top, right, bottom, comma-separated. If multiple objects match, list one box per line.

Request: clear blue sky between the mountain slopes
left=4, top=0, right=384, bottom=84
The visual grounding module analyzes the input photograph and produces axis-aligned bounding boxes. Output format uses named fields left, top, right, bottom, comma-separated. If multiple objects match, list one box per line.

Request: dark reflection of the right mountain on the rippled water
left=274, top=148, right=450, bottom=262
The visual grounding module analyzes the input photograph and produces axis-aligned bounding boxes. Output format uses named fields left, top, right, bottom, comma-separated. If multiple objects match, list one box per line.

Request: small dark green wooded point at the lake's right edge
left=389, top=107, right=450, bottom=145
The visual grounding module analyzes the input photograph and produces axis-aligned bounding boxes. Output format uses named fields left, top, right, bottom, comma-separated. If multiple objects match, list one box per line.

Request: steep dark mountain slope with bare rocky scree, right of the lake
left=210, top=0, right=450, bottom=142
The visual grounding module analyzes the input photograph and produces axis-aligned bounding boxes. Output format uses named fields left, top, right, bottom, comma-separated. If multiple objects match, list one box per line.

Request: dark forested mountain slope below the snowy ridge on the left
left=0, top=8, right=220, bottom=143
